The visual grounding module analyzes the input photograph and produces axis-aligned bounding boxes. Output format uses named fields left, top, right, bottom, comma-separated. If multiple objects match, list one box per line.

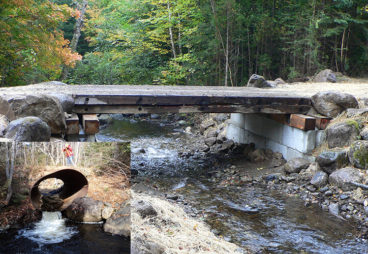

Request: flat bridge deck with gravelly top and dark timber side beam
left=0, top=83, right=368, bottom=114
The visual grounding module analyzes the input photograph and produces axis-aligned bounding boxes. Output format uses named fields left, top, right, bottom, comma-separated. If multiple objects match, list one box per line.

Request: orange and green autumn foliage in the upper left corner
left=0, top=0, right=80, bottom=86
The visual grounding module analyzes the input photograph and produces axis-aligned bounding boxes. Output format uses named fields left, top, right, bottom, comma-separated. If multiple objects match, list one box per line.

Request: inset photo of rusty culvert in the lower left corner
left=0, top=142, right=131, bottom=254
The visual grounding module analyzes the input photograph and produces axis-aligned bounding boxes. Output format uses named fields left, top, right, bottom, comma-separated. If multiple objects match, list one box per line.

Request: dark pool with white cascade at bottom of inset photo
left=0, top=212, right=130, bottom=254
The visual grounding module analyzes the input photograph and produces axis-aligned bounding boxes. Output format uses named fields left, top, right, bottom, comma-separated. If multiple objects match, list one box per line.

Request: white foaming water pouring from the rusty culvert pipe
left=19, top=211, right=78, bottom=245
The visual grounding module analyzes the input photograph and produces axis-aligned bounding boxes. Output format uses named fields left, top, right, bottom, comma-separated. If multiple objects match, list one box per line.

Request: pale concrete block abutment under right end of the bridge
left=227, top=113, right=324, bottom=160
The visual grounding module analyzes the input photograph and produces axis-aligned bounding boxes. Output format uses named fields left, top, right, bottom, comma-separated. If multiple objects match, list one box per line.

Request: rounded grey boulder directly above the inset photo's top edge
left=5, top=116, right=51, bottom=142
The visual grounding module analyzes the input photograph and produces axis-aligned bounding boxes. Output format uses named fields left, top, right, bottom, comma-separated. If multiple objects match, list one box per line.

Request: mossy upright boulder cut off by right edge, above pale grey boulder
left=348, top=140, right=368, bottom=169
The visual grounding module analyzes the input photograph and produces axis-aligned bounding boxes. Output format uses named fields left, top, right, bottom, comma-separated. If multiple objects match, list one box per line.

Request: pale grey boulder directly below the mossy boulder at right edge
left=328, top=167, right=363, bottom=191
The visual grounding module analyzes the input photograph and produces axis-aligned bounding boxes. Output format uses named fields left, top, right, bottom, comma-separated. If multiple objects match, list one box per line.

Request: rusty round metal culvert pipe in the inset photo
left=31, top=169, right=88, bottom=211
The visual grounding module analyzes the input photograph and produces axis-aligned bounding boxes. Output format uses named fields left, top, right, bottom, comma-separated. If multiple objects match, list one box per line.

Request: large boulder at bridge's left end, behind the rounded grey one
left=8, top=95, right=66, bottom=134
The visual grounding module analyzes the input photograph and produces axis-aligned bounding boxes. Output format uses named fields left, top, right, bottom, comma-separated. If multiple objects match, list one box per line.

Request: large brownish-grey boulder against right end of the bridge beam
left=311, top=91, right=358, bottom=118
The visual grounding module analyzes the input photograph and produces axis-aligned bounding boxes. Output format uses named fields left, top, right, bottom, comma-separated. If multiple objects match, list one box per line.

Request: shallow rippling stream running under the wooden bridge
left=98, top=115, right=368, bottom=253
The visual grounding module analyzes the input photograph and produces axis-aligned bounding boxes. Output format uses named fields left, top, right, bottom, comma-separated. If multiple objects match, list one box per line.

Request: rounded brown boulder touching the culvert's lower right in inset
left=65, top=197, right=104, bottom=222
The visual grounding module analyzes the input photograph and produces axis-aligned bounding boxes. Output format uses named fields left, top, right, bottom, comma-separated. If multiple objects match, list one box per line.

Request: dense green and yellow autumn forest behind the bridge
left=0, top=0, right=368, bottom=86
